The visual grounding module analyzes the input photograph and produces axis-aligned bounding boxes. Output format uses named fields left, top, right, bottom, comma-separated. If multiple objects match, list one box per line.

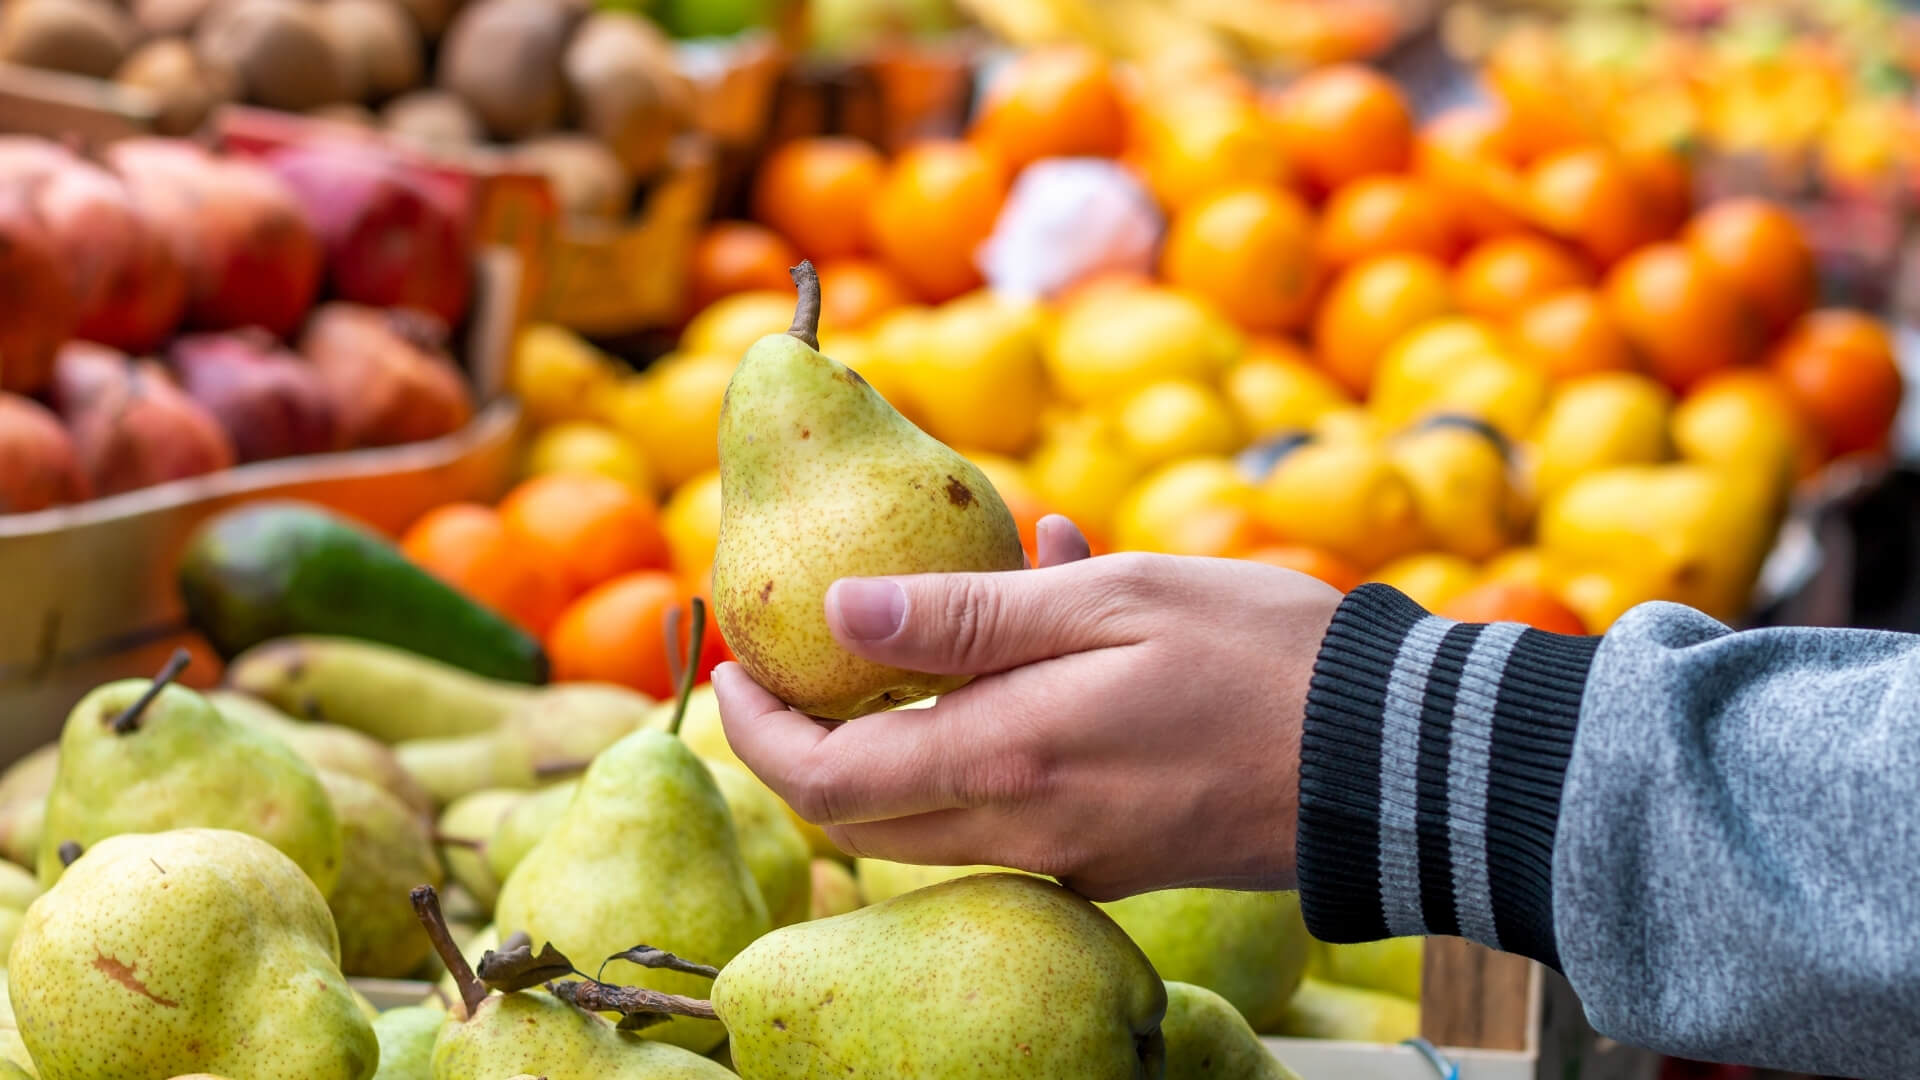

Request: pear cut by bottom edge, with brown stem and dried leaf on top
left=432, top=990, right=733, bottom=1080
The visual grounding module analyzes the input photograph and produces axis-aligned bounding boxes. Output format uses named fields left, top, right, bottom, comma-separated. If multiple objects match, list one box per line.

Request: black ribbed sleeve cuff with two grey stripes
left=1298, top=584, right=1599, bottom=967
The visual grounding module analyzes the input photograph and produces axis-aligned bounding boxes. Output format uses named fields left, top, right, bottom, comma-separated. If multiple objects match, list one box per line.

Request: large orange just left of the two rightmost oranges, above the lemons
left=1605, top=244, right=1757, bottom=390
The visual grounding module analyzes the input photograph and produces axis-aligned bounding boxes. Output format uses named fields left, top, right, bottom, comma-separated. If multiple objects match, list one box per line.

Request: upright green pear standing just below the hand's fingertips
left=493, top=730, right=772, bottom=1051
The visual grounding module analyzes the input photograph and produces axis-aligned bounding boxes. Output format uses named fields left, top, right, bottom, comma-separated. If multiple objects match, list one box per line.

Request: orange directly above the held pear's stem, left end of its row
left=753, top=135, right=887, bottom=261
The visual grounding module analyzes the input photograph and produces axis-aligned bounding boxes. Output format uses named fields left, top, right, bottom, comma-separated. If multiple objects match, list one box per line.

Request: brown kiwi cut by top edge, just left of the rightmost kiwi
left=440, top=0, right=580, bottom=140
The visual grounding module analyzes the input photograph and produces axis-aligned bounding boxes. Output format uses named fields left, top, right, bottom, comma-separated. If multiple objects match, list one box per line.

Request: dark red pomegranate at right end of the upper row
left=269, top=142, right=472, bottom=327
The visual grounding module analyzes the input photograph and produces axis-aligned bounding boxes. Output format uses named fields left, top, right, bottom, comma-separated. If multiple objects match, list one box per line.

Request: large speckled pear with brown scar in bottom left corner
left=8, top=828, right=380, bottom=1080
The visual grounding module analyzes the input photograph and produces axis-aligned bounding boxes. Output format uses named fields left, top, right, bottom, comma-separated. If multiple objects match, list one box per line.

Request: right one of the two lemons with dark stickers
left=1386, top=423, right=1524, bottom=557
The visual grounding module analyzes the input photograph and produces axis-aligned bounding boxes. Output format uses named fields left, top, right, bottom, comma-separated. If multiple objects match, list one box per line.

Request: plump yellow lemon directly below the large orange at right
left=1532, top=371, right=1672, bottom=496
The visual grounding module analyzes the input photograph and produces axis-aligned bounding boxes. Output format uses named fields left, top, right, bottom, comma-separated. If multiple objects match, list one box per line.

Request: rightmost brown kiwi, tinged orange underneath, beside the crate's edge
left=561, top=12, right=693, bottom=177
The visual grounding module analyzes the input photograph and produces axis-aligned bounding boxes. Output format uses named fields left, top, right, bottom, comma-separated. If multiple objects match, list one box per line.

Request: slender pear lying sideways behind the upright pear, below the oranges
left=394, top=682, right=655, bottom=803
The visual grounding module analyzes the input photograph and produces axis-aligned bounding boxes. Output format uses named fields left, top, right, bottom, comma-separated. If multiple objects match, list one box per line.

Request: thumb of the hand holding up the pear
left=826, top=559, right=1117, bottom=675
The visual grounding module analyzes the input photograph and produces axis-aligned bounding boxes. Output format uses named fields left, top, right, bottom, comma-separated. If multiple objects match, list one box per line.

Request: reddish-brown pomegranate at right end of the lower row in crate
left=300, top=304, right=472, bottom=446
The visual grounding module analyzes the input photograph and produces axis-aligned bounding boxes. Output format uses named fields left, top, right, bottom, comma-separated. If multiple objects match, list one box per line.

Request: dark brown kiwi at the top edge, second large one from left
left=194, top=0, right=348, bottom=113
